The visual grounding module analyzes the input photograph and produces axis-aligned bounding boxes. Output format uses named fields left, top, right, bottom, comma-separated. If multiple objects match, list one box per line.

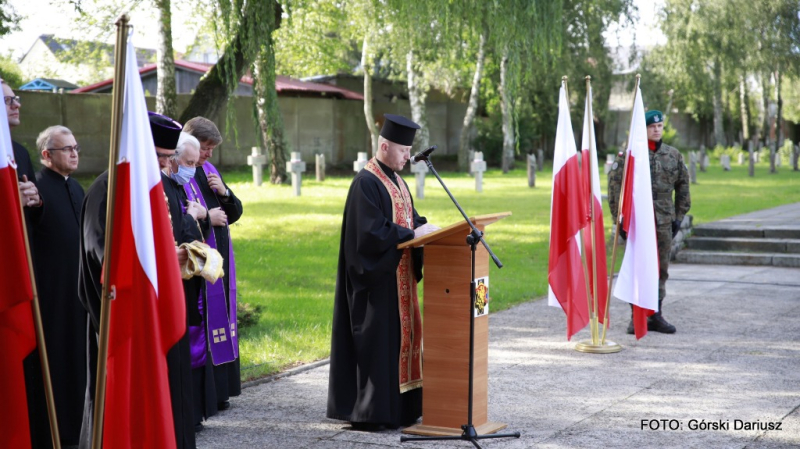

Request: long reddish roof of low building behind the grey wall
left=72, top=59, right=364, bottom=101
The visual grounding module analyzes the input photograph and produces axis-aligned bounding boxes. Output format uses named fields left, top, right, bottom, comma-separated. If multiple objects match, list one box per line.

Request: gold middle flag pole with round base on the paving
left=575, top=75, right=622, bottom=354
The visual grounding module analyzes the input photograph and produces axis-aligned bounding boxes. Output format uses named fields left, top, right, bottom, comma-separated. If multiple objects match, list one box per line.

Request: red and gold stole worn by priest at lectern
left=364, top=158, right=422, bottom=393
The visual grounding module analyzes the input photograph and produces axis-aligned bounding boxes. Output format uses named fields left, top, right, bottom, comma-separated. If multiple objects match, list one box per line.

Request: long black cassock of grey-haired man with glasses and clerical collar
left=31, top=167, right=87, bottom=445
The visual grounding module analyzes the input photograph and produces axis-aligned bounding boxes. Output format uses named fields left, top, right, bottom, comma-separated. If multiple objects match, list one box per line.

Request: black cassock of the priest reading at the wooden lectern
left=327, top=164, right=427, bottom=428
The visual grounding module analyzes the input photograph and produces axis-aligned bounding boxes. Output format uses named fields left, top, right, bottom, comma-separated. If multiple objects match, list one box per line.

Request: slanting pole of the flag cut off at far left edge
left=14, top=176, right=61, bottom=449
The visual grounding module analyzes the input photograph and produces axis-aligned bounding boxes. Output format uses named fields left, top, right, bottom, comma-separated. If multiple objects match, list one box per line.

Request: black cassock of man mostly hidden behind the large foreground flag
left=78, top=171, right=201, bottom=449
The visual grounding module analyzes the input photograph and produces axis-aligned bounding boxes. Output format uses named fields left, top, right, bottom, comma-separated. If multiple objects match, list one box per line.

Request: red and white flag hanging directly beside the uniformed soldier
left=614, top=87, right=658, bottom=339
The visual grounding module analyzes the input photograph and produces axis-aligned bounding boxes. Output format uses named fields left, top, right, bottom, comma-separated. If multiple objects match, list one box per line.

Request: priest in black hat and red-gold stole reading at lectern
left=327, top=114, right=438, bottom=431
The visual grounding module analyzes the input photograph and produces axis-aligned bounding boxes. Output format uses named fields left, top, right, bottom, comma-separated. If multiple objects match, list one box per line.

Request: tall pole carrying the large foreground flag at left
left=92, top=14, right=130, bottom=449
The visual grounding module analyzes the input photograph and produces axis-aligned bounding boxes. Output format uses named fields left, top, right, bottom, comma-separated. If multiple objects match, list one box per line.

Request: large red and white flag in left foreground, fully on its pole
left=103, top=41, right=186, bottom=448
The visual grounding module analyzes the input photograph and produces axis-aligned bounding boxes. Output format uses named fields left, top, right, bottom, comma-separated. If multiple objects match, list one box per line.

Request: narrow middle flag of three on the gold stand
left=581, top=86, right=608, bottom=323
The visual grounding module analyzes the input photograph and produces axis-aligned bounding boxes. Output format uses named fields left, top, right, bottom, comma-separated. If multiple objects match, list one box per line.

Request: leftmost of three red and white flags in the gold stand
left=547, top=84, right=589, bottom=340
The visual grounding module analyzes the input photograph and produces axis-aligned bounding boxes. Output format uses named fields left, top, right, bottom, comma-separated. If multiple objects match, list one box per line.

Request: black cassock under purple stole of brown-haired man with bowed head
left=194, top=167, right=243, bottom=405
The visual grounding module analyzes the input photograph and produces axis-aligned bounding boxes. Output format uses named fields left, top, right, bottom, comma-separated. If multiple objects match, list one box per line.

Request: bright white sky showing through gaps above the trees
left=0, top=0, right=666, bottom=60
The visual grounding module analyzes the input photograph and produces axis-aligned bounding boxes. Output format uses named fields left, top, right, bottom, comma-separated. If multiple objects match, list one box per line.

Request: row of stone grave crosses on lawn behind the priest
left=247, top=147, right=544, bottom=199
